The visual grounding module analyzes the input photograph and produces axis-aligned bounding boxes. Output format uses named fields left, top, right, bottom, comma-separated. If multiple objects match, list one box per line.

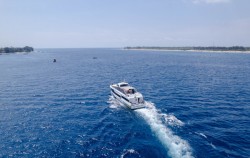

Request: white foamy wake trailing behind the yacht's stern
left=135, top=102, right=193, bottom=158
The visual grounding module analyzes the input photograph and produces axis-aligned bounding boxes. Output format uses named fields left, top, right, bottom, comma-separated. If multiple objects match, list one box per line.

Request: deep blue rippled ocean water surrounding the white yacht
left=0, top=49, right=250, bottom=158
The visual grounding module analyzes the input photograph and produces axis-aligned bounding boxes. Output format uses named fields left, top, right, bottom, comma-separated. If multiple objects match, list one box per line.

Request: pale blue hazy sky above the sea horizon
left=0, top=0, right=250, bottom=48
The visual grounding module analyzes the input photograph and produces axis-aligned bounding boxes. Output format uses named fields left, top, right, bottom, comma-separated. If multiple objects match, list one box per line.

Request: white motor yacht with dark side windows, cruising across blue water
left=110, top=82, right=145, bottom=110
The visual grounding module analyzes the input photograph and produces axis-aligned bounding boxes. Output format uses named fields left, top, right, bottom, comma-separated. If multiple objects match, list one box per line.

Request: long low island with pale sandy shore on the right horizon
left=124, top=46, right=250, bottom=52
